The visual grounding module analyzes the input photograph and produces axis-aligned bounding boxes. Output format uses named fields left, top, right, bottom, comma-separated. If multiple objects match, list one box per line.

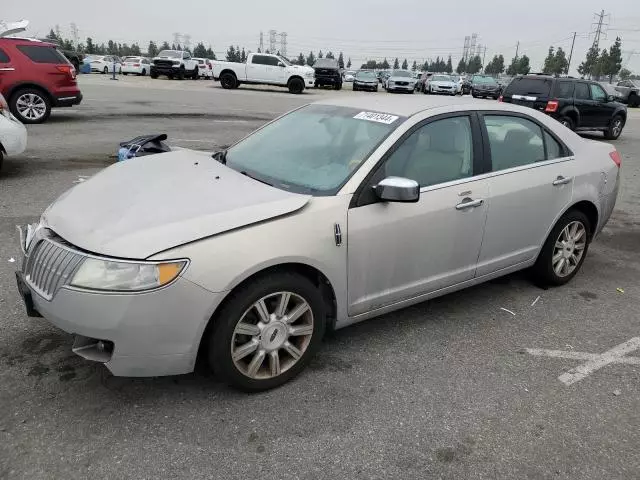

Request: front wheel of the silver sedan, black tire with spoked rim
left=206, top=273, right=326, bottom=392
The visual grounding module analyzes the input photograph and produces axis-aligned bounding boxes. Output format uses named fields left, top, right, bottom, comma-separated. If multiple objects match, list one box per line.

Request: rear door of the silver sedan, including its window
left=476, top=113, right=575, bottom=277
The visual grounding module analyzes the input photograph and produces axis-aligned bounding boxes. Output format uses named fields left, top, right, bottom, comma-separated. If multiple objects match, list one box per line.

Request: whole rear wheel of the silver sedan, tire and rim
left=533, top=210, right=592, bottom=285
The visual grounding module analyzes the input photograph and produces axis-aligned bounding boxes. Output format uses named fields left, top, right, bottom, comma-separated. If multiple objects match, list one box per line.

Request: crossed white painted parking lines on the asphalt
left=526, top=337, right=640, bottom=385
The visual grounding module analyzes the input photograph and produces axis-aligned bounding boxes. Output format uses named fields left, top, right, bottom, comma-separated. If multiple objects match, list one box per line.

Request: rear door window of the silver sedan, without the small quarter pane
left=484, top=115, right=545, bottom=172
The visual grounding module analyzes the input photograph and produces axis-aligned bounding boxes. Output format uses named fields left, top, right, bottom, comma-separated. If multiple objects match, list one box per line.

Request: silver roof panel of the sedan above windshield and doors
left=314, top=95, right=531, bottom=117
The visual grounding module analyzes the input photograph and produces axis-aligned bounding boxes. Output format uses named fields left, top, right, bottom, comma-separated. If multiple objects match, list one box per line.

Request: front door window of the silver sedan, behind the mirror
left=384, top=116, right=473, bottom=187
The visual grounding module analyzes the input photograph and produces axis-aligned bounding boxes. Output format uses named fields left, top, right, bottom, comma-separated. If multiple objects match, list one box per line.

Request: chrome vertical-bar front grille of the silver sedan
left=23, top=237, right=85, bottom=300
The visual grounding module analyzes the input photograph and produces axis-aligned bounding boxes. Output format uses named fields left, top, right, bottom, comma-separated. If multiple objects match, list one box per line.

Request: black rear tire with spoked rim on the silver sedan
left=533, top=210, right=593, bottom=286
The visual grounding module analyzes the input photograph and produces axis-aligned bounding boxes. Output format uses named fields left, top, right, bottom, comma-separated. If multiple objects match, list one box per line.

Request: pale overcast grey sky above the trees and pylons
left=0, top=0, right=640, bottom=74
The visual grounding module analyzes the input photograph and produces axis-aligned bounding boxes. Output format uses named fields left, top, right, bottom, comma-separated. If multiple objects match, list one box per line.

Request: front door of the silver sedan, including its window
left=348, top=115, right=489, bottom=316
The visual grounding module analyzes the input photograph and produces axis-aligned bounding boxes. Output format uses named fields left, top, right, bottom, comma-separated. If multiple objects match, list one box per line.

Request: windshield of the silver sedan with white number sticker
left=226, top=105, right=404, bottom=195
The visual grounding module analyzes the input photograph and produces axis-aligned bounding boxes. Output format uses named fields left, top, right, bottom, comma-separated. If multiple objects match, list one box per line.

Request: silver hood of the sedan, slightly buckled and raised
left=42, top=150, right=311, bottom=259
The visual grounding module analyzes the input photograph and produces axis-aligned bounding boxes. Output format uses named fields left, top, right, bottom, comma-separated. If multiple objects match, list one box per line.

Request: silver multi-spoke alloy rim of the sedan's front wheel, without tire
left=231, top=292, right=314, bottom=380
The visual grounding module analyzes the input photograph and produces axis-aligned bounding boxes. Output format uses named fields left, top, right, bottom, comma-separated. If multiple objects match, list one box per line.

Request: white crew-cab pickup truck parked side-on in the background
left=213, top=53, right=315, bottom=93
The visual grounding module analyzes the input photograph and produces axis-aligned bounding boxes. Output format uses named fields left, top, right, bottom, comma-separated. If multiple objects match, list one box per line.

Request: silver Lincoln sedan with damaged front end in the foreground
left=17, top=96, right=620, bottom=391
